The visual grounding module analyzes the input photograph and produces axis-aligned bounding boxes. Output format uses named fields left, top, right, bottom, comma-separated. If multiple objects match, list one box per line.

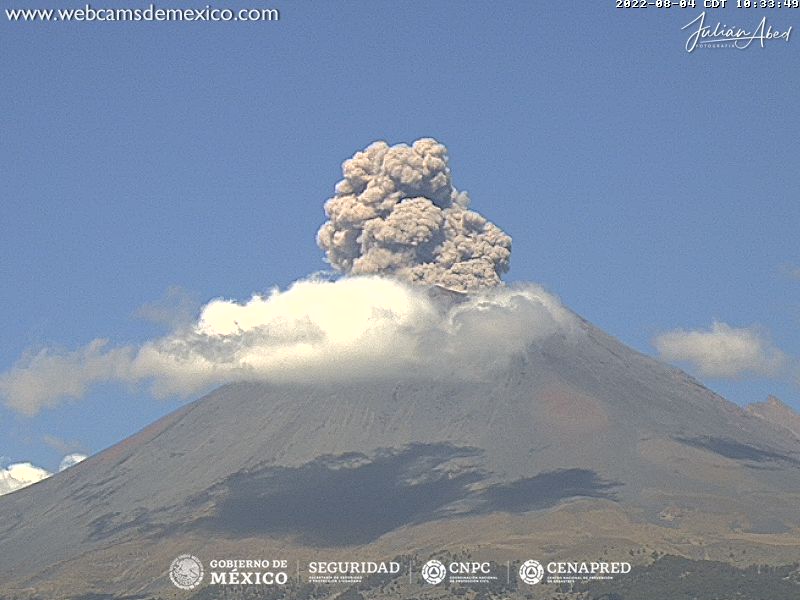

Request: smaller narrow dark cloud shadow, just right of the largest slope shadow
left=481, top=469, right=622, bottom=512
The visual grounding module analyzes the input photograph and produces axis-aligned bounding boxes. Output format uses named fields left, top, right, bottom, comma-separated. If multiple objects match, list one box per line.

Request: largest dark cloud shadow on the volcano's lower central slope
left=191, top=444, right=484, bottom=545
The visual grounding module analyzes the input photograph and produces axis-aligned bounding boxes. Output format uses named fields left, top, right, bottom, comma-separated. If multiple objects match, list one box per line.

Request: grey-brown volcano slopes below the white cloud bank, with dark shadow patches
left=0, top=302, right=800, bottom=598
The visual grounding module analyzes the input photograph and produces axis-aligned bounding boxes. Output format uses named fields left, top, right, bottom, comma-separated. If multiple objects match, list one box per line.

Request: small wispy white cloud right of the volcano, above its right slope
left=653, top=322, right=787, bottom=377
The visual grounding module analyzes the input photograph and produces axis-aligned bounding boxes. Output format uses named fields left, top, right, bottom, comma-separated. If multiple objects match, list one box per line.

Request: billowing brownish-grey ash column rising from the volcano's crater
left=317, top=138, right=511, bottom=291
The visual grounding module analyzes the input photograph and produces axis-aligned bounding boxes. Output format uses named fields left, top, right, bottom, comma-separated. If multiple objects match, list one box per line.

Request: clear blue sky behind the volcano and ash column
left=0, top=0, right=800, bottom=470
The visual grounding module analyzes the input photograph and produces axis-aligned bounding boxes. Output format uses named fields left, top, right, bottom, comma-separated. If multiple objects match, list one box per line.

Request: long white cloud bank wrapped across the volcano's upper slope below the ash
left=0, top=276, right=575, bottom=414
